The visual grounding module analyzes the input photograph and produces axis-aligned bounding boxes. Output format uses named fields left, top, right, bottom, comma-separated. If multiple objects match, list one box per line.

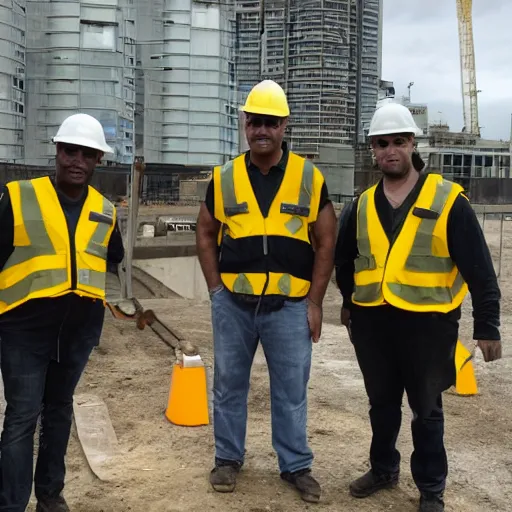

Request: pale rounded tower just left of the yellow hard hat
left=136, top=0, right=238, bottom=165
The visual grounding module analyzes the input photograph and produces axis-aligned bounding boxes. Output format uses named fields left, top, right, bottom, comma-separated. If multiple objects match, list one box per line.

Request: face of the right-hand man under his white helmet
left=372, top=134, right=414, bottom=179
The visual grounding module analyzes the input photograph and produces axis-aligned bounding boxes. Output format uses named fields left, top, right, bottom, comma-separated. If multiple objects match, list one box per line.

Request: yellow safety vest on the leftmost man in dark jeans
left=0, top=177, right=116, bottom=314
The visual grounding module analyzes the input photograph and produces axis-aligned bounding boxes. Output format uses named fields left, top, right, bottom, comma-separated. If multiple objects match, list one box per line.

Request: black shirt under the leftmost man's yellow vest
left=0, top=181, right=124, bottom=329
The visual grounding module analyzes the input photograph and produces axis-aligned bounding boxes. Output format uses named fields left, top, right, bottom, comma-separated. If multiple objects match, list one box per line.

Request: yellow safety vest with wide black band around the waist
left=213, top=152, right=324, bottom=298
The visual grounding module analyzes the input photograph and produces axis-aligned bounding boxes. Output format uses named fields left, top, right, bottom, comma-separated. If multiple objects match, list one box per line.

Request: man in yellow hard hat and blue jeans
left=197, top=80, right=336, bottom=502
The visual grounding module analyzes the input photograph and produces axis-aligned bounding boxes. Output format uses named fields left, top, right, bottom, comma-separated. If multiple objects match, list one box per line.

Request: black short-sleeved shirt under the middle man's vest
left=204, top=142, right=331, bottom=217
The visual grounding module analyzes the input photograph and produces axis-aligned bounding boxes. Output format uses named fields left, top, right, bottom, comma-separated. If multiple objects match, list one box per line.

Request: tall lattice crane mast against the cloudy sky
left=456, top=0, right=480, bottom=137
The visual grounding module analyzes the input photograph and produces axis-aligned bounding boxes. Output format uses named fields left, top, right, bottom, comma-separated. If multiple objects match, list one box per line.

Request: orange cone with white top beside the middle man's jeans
left=165, top=355, right=209, bottom=427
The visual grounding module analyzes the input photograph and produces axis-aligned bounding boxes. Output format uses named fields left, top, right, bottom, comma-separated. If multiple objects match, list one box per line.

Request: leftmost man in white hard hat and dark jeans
left=0, top=114, right=124, bottom=512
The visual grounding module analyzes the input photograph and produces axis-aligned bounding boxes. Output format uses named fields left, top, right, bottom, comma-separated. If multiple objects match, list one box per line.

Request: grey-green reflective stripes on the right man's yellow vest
left=354, top=180, right=464, bottom=305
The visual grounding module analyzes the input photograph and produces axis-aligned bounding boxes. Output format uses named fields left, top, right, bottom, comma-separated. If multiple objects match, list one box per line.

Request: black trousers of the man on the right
left=351, top=306, right=458, bottom=494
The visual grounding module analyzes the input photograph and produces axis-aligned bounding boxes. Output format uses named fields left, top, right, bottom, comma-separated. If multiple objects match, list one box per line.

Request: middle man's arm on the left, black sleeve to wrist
left=196, top=179, right=222, bottom=290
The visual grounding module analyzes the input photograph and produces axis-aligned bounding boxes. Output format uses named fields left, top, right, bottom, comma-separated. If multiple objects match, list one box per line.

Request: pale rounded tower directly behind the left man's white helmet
left=25, top=0, right=136, bottom=165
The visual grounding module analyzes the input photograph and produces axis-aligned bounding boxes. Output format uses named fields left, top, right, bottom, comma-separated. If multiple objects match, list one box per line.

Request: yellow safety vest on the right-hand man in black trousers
left=352, top=174, right=468, bottom=313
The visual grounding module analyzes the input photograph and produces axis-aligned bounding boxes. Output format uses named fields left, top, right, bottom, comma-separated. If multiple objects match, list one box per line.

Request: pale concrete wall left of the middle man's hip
left=133, top=256, right=210, bottom=300
